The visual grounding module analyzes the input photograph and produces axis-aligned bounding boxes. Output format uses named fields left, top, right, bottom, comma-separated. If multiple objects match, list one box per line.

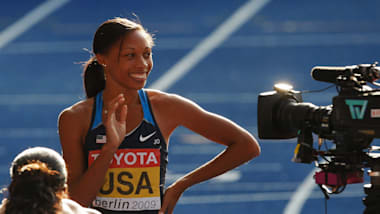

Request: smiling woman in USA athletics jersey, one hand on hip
left=59, top=18, right=260, bottom=213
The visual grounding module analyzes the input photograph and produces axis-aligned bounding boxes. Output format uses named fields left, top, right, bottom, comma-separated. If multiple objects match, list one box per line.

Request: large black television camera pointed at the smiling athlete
left=257, top=62, right=380, bottom=214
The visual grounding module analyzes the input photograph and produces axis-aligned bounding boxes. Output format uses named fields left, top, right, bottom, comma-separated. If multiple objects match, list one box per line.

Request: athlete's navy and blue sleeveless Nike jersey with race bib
left=84, top=89, right=168, bottom=214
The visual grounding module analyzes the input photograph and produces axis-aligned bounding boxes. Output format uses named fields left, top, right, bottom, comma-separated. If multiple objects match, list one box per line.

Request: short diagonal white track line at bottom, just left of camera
left=283, top=168, right=317, bottom=214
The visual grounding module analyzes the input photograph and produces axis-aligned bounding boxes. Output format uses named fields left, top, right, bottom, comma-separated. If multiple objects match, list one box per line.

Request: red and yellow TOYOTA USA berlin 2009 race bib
left=88, top=149, right=161, bottom=211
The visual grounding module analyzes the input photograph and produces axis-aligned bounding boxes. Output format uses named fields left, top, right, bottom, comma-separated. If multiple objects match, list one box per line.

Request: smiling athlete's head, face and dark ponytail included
left=84, top=18, right=154, bottom=98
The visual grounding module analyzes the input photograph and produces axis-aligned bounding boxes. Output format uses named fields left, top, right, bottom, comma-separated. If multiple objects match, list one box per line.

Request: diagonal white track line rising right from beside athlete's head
left=150, top=0, right=270, bottom=91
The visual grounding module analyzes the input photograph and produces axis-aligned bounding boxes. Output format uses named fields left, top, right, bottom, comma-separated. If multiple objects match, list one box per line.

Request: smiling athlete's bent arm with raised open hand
left=59, top=94, right=127, bottom=206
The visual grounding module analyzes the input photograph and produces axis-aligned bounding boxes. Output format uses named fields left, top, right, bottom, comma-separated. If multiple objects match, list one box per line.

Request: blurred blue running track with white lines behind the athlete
left=0, top=0, right=380, bottom=214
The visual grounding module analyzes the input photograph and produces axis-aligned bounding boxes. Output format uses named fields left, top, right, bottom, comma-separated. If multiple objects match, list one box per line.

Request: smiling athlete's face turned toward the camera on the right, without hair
left=103, top=30, right=153, bottom=90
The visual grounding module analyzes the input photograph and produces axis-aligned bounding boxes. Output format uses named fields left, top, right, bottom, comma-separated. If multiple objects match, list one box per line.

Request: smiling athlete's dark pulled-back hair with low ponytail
left=83, top=17, right=154, bottom=98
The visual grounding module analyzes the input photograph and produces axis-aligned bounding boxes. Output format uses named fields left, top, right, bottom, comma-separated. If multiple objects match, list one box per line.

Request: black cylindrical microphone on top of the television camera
left=311, top=66, right=347, bottom=83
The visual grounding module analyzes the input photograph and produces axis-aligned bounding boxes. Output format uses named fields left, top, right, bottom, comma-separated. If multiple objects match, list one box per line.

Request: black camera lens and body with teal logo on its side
left=257, top=90, right=380, bottom=139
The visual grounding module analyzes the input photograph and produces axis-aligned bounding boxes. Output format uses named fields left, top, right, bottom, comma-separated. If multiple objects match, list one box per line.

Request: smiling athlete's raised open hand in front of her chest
left=104, top=94, right=128, bottom=149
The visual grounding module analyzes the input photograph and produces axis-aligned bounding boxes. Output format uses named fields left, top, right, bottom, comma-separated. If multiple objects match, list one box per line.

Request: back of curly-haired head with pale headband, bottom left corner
left=5, top=147, right=67, bottom=214
